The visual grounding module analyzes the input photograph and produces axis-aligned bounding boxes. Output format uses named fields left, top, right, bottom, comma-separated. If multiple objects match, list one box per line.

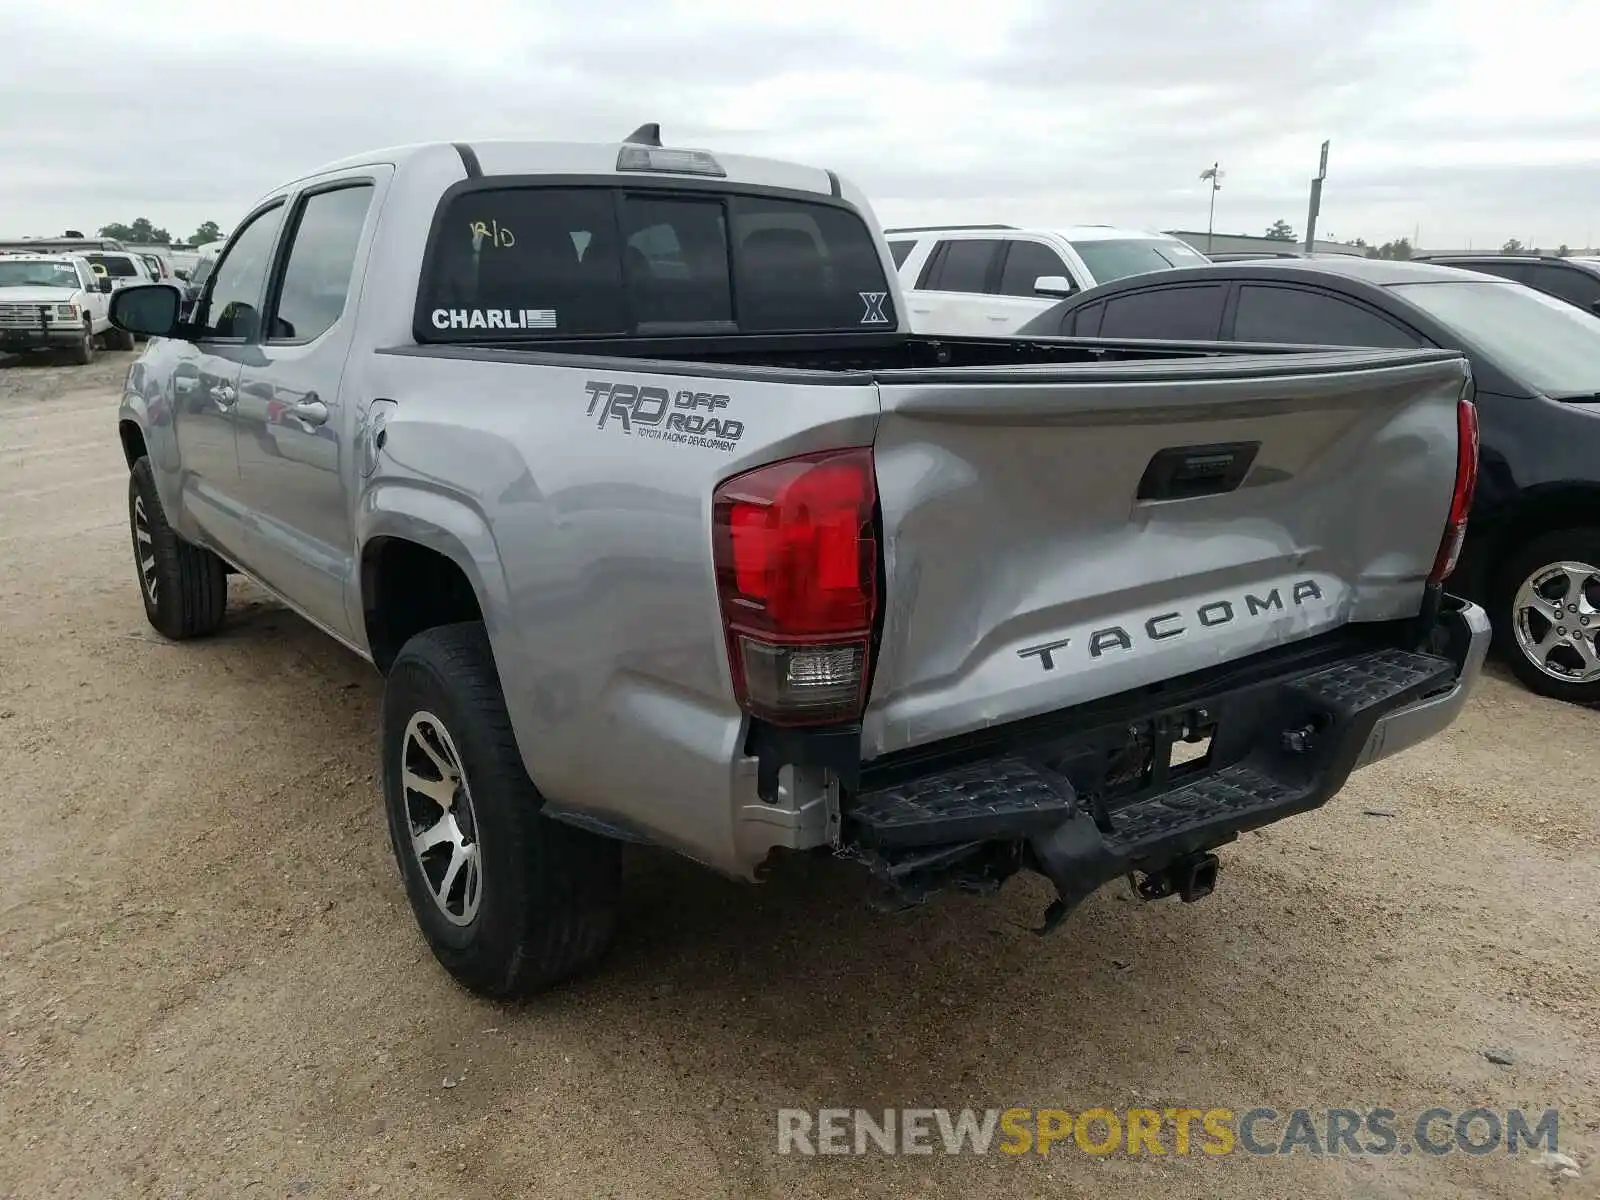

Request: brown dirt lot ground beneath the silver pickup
left=0, top=354, right=1600, bottom=1198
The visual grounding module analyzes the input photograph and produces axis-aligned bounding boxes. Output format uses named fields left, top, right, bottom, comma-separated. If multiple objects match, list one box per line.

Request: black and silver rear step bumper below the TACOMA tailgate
left=842, top=598, right=1490, bottom=915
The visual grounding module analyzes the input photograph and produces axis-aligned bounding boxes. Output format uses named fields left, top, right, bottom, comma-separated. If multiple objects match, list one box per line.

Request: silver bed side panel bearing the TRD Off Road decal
left=368, top=350, right=878, bottom=874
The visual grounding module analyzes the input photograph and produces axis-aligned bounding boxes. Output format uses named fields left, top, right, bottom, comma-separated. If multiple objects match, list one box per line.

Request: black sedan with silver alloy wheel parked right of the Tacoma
left=1018, top=258, right=1600, bottom=702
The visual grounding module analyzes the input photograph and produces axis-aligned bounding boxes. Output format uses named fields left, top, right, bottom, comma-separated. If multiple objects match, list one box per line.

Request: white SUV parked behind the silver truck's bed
left=883, top=226, right=1208, bottom=336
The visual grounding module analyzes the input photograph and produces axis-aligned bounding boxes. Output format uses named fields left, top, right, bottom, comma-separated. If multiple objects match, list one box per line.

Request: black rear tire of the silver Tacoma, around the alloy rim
left=382, top=621, right=622, bottom=1000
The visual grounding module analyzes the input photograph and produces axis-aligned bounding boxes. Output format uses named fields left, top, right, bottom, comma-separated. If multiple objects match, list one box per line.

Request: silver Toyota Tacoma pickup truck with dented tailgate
left=112, top=126, right=1490, bottom=997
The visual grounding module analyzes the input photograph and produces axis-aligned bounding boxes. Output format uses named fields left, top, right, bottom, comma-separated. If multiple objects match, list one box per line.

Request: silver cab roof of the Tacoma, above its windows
left=283, top=139, right=840, bottom=203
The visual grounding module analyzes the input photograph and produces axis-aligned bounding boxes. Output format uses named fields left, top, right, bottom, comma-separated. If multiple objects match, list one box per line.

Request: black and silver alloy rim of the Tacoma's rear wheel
left=400, top=712, right=483, bottom=925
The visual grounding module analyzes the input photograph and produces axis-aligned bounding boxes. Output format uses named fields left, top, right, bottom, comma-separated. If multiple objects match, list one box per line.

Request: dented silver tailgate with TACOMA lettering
left=862, top=350, right=1469, bottom=758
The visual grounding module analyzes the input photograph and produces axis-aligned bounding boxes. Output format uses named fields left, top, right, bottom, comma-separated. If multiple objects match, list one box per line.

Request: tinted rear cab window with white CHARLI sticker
left=414, top=186, right=898, bottom=342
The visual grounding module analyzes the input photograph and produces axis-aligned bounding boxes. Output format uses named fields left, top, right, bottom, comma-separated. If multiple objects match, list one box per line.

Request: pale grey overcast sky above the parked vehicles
left=0, top=0, right=1600, bottom=248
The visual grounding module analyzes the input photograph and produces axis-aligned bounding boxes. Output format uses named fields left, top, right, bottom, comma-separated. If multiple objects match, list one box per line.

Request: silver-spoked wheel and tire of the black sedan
left=1493, top=528, right=1600, bottom=704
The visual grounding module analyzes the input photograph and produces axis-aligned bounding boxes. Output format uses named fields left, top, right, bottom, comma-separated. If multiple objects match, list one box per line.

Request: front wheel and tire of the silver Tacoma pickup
left=128, top=458, right=227, bottom=642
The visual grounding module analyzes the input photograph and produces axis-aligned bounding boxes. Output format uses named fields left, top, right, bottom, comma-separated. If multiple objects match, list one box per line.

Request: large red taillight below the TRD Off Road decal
left=712, top=450, right=878, bottom=725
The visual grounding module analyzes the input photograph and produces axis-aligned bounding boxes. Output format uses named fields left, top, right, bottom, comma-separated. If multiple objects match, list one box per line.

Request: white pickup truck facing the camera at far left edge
left=0, top=253, right=134, bottom=363
